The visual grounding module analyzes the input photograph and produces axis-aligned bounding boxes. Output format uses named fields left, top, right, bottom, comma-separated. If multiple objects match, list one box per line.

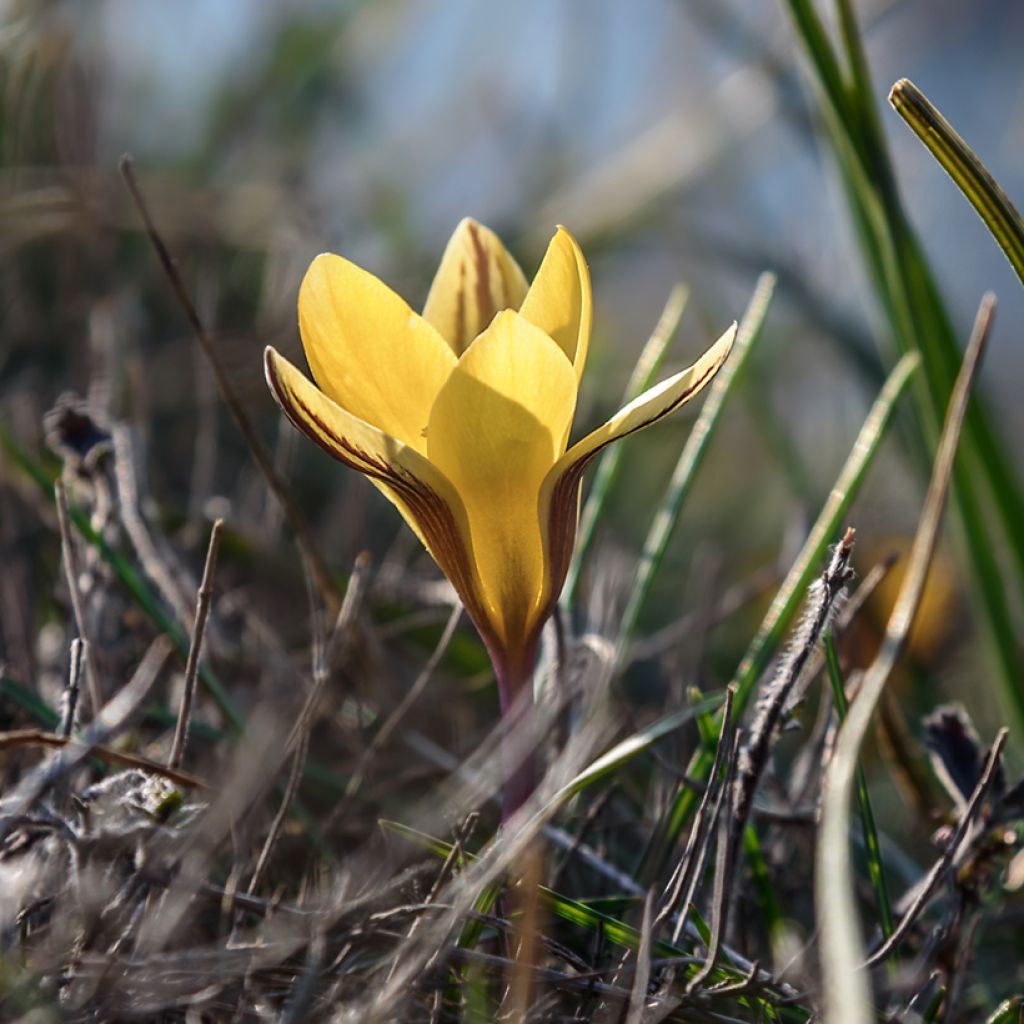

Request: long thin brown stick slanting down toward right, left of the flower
left=118, top=154, right=341, bottom=612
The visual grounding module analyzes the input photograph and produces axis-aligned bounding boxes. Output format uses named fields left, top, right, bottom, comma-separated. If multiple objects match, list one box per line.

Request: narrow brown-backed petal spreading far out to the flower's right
left=541, top=324, right=736, bottom=600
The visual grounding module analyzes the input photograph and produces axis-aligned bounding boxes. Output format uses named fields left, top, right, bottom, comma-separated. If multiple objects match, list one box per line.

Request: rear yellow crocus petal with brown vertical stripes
left=423, top=217, right=526, bottom=355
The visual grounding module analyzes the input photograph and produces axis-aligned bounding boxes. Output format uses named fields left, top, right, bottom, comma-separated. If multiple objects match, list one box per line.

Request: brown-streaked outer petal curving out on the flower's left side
left=265, top=346, right=482, bottom=634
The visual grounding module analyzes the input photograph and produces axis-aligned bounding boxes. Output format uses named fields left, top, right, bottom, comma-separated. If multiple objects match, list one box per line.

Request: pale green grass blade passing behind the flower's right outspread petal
left=561, top=284, right=689, bottom=608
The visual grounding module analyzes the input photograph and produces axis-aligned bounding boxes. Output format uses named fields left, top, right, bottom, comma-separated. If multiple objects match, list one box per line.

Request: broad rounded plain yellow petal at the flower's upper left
left=299, top=253, right=456, bottom=452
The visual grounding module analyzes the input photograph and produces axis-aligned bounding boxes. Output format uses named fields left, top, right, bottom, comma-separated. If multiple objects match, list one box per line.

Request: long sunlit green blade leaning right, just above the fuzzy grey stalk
left=640, top=354, right=921, bottom=883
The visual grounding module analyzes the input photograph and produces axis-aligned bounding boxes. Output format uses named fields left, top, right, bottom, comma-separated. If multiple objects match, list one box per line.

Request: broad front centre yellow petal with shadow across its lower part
left=427, top=311, right=577, bottom=649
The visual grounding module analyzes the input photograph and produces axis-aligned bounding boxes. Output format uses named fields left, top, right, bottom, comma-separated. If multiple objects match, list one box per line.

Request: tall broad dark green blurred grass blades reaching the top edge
left=783, top=0, right=1024, bottom=727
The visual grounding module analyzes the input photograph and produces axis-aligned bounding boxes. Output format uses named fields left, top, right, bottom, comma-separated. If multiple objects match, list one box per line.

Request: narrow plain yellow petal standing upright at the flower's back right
left=519, top=226, right=591, bottom=380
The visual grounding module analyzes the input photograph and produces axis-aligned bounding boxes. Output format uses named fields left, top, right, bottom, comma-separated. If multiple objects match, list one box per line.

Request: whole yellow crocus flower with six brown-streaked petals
left=266, top=219, right=735, bottom=710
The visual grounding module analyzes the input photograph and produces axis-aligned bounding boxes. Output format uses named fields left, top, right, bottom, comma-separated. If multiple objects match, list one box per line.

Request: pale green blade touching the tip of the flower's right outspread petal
left=618, top=273, right=775, bottom=653
